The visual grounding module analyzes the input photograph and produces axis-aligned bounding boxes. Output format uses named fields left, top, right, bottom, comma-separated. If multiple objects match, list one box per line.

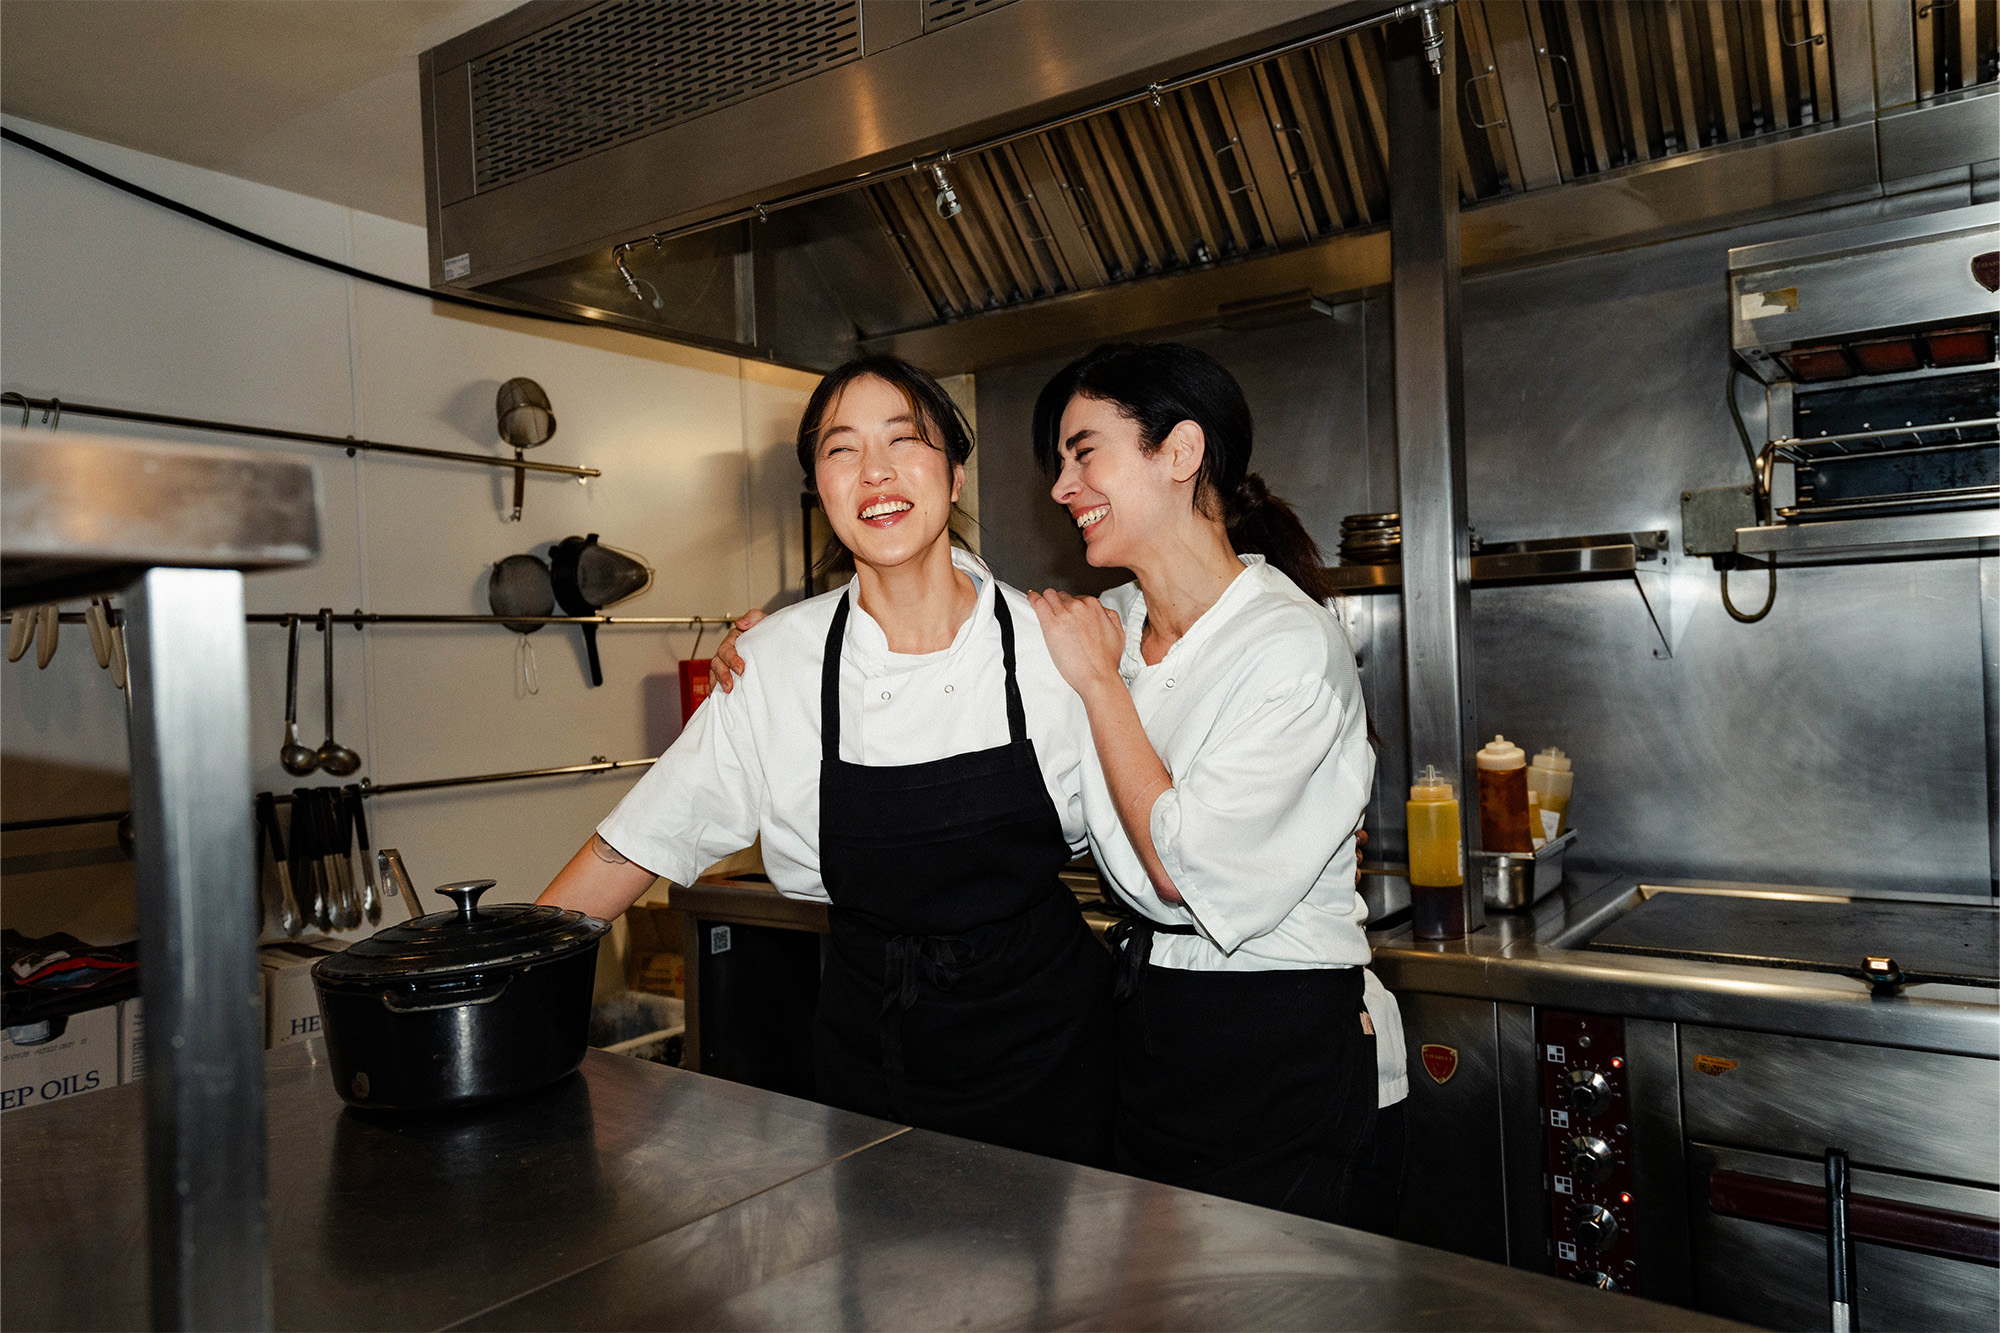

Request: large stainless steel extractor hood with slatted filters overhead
left=422, top=0, right=2000, bottom=370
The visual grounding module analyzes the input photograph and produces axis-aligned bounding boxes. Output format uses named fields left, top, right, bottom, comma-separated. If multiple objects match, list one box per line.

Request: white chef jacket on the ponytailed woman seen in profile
left=1084, top=554, right=1408, bottom=1105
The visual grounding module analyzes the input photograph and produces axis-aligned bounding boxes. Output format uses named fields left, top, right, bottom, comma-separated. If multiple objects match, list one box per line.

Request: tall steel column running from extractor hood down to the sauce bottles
left=1388, top=6, right=1486, bottom=939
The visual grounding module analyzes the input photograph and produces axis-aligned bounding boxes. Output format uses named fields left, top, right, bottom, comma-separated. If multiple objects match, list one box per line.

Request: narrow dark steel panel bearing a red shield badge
left=1394, top=993, right=1508, bottom=1263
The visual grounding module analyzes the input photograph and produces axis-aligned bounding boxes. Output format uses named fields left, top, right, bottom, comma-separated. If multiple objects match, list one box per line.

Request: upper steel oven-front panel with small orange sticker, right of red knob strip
left=1680, top=1025, right=2000, bottom=1189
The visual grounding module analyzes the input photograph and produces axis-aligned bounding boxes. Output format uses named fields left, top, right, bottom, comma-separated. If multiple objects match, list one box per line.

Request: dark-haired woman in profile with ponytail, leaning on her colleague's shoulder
left=1030, top=344, right=1402, bottom=1229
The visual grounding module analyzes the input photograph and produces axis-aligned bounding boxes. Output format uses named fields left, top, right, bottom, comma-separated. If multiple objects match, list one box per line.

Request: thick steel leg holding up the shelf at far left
left=124, top=568, right=272, bottom=1329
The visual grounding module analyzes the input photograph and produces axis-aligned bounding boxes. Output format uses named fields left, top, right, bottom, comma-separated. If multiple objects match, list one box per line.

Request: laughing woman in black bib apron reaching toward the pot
left=542, top=356, right=1114, bottom=1163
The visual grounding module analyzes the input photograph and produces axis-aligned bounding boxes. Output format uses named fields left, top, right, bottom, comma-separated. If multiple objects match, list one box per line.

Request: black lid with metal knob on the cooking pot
left=312, top=879, right=610, bottom=985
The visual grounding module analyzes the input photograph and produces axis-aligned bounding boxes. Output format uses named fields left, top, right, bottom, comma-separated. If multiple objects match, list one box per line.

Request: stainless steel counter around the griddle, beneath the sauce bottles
left=1370, top=875, right=2000, bottom=1059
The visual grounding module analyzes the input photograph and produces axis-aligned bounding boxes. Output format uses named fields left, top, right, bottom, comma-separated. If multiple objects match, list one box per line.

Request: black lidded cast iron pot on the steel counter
left=312, top=879, right=610, bottom=1111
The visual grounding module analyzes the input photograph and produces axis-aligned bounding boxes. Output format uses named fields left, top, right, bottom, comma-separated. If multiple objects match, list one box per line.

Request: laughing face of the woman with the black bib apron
left=812, top=374, right=966, bottom=568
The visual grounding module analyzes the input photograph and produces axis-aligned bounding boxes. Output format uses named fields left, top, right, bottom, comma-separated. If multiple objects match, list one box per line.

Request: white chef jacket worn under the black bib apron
left=598, top=548, right=1090, bottom=903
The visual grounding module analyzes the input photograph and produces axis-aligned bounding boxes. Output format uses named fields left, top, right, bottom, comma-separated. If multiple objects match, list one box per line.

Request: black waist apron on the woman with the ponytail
left=1112, top=921, right=1376, bottom=1225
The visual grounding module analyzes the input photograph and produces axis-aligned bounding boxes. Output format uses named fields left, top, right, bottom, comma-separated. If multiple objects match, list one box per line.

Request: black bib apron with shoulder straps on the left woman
left=812, top=588, right=1116, bottom=1165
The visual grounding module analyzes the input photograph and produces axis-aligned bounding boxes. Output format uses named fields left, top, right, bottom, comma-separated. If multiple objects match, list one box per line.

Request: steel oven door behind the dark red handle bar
left=1688, top=1143, right=2000, bottom=1329
